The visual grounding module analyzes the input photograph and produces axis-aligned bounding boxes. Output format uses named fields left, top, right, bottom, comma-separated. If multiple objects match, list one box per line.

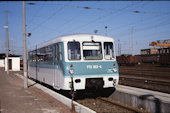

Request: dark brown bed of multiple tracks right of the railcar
left=119, top=64, right=170, bottom=93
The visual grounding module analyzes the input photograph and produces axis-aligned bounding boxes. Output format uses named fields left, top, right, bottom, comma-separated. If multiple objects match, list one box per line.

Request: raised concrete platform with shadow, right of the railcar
left=110, top=85, right=170, bottom=113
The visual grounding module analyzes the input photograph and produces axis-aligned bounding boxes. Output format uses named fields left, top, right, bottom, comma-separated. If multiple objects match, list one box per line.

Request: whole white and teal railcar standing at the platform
left=28, top=34, right=119, bottom=91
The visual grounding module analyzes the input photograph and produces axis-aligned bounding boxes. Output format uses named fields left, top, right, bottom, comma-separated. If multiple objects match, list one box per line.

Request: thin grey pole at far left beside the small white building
left=5, top=11, right=9, bottom=75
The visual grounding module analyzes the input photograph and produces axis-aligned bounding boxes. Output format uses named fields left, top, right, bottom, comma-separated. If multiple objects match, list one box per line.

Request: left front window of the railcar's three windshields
left=68, top=42, right=81, bottom=60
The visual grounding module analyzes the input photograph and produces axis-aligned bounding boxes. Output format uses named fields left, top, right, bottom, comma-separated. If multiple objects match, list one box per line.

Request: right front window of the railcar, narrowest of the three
left=104, top=42, right=114, bottom=60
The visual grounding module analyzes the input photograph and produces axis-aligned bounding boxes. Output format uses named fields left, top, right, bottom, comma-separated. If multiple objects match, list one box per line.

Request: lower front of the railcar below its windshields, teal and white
left=66, top=61, right=119, bottom=90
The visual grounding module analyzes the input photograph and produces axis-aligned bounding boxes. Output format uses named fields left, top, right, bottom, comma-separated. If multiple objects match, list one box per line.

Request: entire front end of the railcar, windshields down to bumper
left=60, top=35, right=119, bottom=91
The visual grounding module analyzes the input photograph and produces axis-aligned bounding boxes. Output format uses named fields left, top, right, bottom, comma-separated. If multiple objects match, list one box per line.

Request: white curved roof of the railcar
left=29, top=34, right=114, bottom=49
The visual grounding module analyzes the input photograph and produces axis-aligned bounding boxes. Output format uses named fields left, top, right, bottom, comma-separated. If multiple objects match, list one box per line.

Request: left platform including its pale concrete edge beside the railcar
left=0, top=68, right=95, bottom=113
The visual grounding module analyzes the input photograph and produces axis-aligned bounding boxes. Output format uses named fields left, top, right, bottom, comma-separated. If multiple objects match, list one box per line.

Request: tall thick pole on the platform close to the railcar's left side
left=22, top=1, right=28, bottom=88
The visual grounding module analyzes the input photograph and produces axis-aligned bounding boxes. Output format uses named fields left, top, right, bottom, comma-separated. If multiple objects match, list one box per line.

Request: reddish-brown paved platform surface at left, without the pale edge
left=0, top=68, right=71, bottom=113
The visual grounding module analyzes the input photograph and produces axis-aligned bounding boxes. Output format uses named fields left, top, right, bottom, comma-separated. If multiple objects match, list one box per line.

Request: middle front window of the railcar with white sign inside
left=83, top=42, right=103, bottom=60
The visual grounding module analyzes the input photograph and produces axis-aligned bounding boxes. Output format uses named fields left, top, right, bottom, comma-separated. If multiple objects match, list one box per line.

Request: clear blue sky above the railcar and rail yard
left=0, top=1, right=170, bottom=54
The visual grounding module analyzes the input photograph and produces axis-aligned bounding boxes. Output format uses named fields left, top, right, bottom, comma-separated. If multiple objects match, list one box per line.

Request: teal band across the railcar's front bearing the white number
left=64, top=61, right=119, bottom=77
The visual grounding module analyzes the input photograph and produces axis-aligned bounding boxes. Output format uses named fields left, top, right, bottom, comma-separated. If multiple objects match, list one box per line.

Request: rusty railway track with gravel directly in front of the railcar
left=77, top=97, right=149, bottom=113
